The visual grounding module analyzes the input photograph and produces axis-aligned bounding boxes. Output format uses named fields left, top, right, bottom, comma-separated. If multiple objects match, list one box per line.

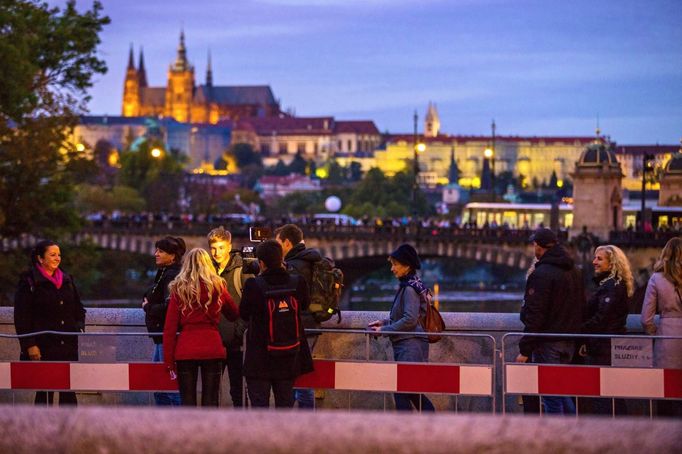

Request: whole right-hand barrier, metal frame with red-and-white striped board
left=502, top=333, right=682, bottom=417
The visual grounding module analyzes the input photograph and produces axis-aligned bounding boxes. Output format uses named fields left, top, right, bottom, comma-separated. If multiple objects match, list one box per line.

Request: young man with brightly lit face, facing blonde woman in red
left=207, top=226, right=253, bottom=408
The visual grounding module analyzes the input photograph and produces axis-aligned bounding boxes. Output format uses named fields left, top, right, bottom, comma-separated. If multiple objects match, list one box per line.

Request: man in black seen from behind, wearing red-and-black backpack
left=239, top=240, right=313, bottom=408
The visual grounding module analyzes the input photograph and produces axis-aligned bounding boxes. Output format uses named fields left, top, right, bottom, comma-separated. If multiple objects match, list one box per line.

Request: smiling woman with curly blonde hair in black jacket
left=582, top=244, right=635, bottom=414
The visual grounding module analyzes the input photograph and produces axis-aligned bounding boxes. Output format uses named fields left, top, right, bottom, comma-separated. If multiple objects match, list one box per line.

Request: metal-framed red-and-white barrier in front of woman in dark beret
left=294, top=329, right=496, bottom=413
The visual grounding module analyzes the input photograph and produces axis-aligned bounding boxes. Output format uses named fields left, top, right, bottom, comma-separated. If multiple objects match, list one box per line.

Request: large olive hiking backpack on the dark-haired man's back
left=308, top=257, right=343, bottom=323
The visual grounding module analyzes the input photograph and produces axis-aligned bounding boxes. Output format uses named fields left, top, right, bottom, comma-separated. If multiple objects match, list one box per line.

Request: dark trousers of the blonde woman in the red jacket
left=176, top=359, right=222, bottom=407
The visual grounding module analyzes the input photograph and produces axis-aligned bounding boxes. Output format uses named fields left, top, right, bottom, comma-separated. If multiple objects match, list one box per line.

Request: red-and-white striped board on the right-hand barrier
left=505, top=364, right=682, bottom=399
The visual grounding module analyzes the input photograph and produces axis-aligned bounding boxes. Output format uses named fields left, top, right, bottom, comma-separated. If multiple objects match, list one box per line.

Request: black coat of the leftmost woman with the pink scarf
left=14, top=268, right=85, bottom=361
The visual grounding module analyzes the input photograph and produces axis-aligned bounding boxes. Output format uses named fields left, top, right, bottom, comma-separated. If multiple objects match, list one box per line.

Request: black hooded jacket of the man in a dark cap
left=519, top=245, right=585, bottom=356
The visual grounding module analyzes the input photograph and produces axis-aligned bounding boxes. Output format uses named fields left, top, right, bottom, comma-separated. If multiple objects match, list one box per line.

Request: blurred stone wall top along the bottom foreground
left=0, top=406, right=682, bottom=454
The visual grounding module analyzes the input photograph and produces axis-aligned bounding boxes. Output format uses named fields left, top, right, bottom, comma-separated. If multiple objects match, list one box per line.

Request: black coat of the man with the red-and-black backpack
left=239, top=268, right=313, bottom=380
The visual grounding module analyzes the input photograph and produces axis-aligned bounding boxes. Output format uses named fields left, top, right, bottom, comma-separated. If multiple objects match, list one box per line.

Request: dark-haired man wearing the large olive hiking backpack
left=275, top=224, right=322, bottom=409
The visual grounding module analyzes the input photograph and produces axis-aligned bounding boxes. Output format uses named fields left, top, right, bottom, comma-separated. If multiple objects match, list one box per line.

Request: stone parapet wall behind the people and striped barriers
left=0, top=307, right=648, bottom=414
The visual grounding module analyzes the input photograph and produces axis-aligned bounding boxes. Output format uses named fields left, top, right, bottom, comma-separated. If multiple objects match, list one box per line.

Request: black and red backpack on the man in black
left=259, top=279, right=301, bottom=357
